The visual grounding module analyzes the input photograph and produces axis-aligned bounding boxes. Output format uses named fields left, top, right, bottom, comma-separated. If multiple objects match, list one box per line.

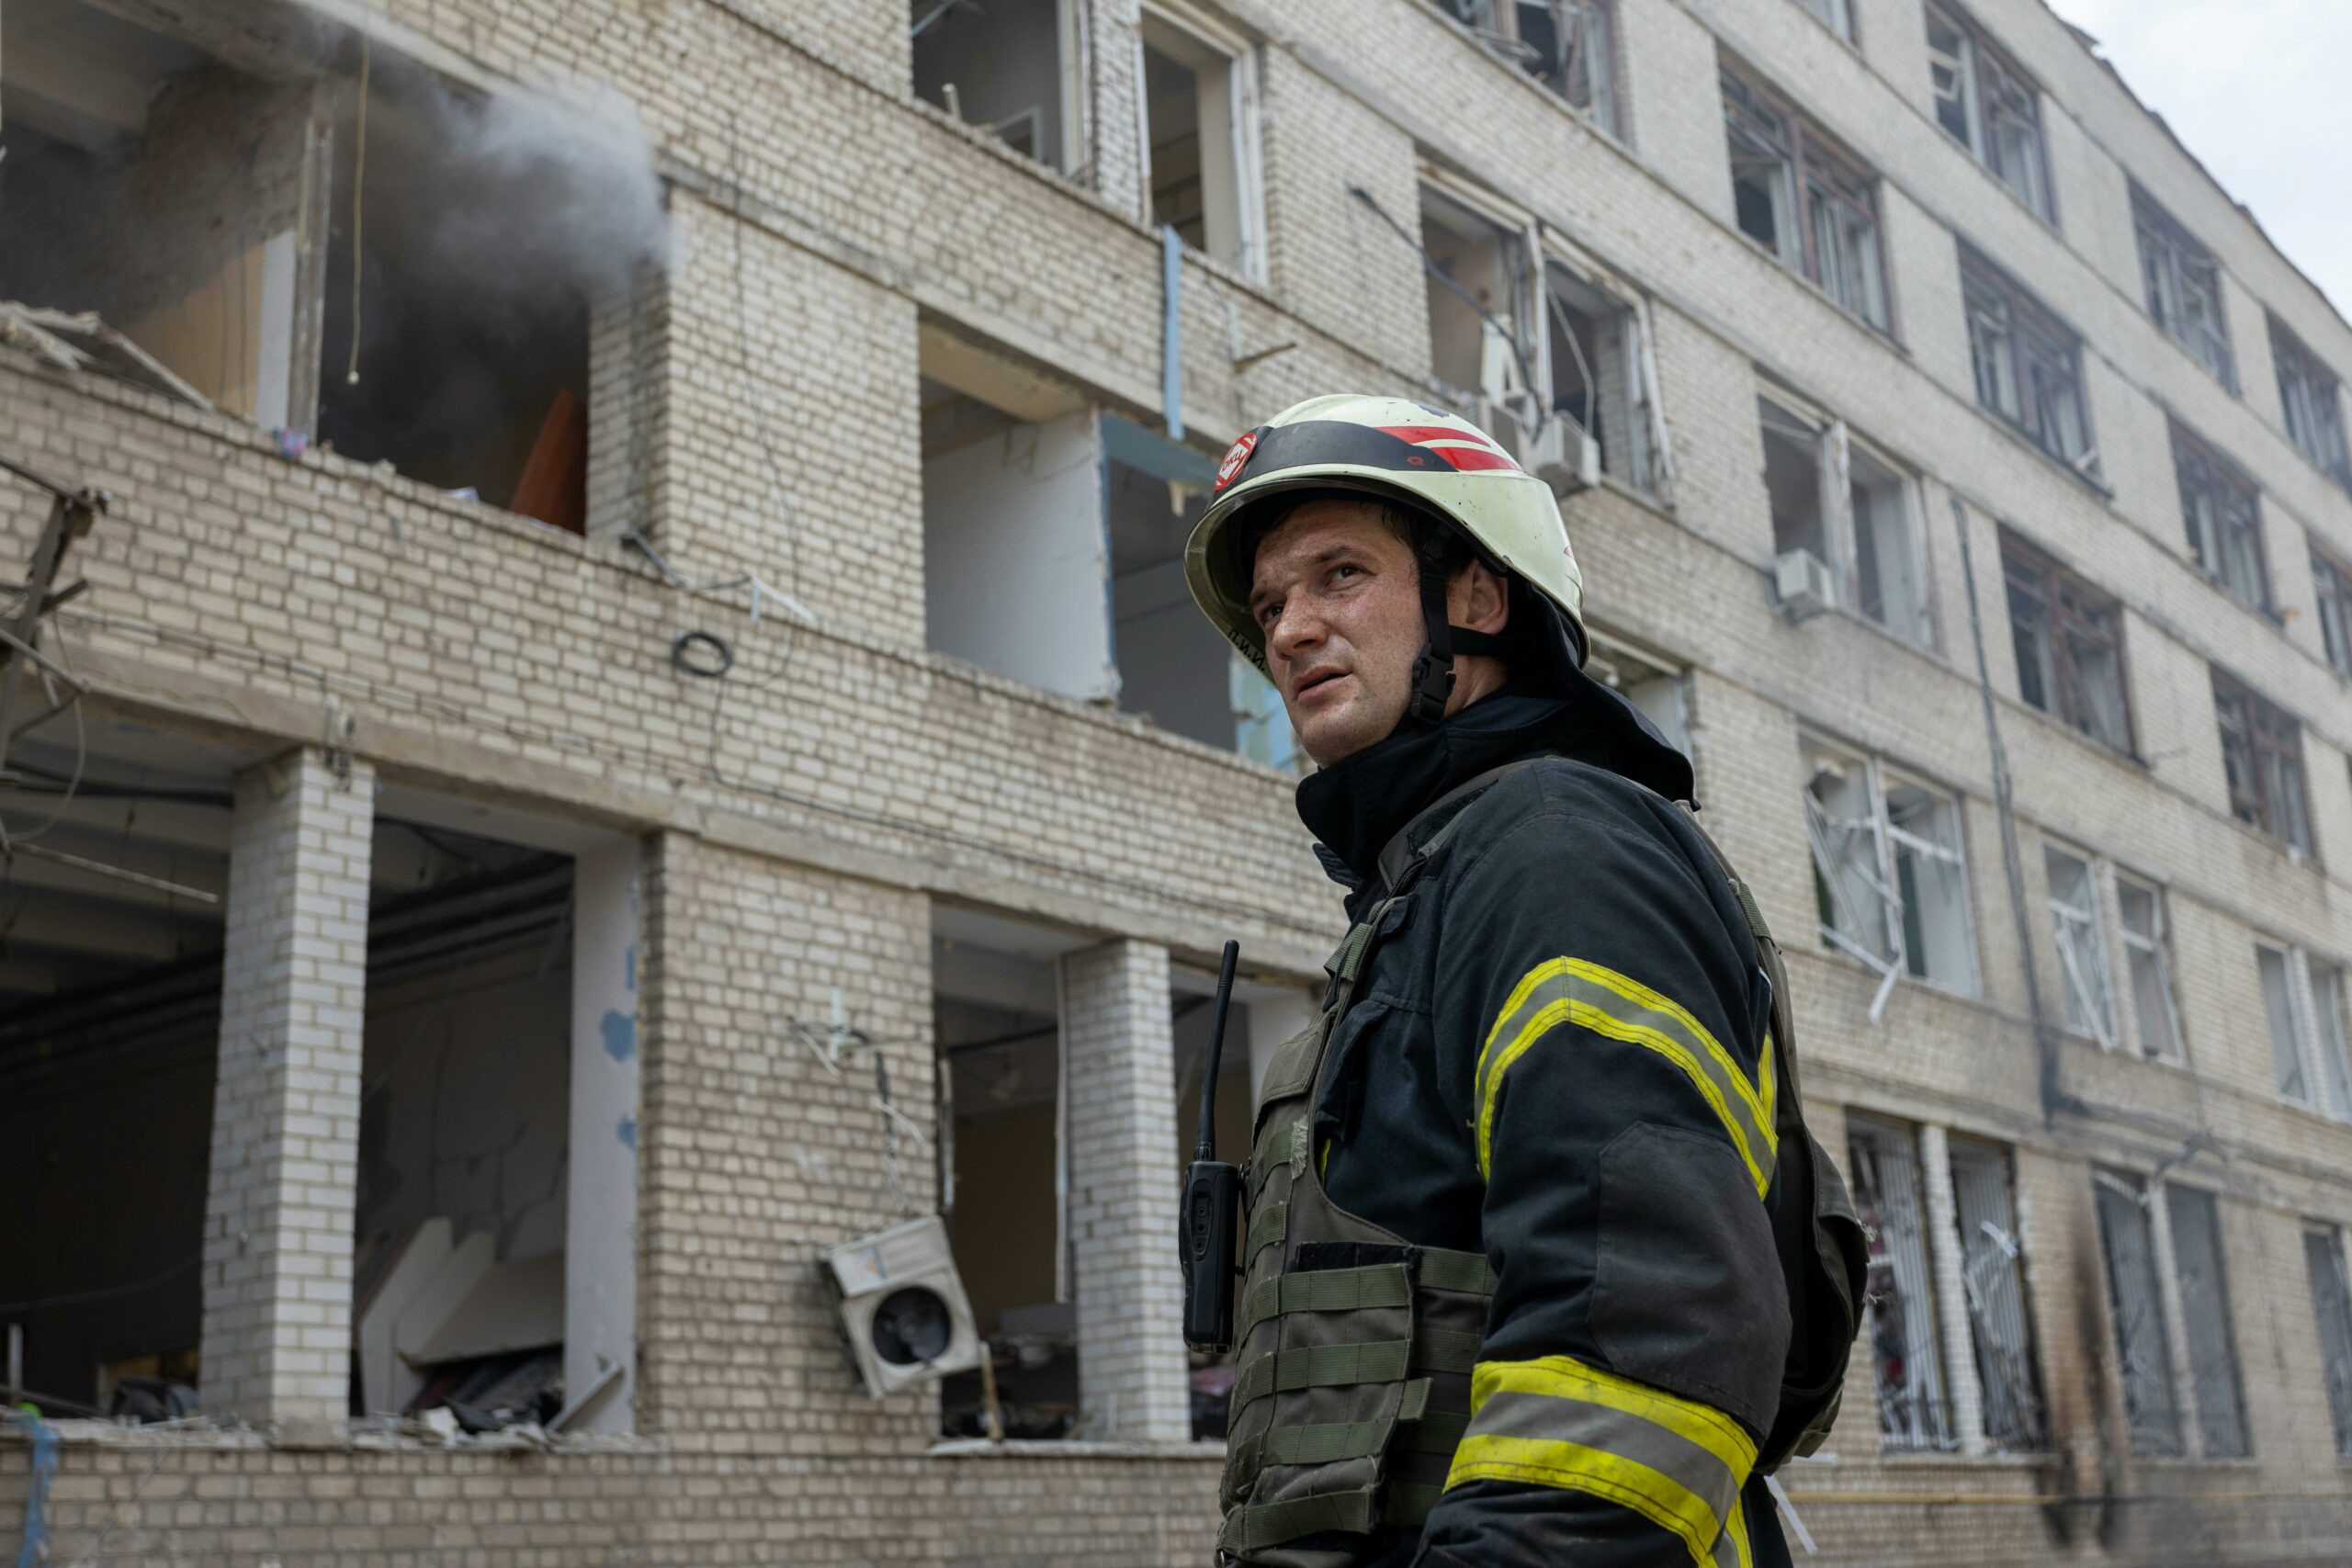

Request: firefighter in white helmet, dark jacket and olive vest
left=1185, top=395, right=1860, bottom=1568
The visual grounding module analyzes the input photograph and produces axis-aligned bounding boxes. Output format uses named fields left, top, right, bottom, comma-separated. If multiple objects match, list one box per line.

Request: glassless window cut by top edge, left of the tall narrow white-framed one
left=908, top=0, right=1082, bottom=172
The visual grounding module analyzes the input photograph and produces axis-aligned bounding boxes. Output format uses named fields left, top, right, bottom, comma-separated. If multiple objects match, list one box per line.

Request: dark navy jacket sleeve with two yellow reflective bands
left=1419, top=785, right=1790, bottom=1568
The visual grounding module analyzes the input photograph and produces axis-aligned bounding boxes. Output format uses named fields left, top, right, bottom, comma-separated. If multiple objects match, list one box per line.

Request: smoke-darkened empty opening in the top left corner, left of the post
left=0, top=0, right=332, bottom=430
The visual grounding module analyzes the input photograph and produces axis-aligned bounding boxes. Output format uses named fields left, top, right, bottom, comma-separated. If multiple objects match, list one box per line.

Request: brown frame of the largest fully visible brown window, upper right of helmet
left=1717, top=63, right=1894, bottom=339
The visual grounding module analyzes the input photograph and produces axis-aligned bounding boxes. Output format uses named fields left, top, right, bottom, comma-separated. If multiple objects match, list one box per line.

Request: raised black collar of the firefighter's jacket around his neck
left=1298, top=672, right=1691, bottom=891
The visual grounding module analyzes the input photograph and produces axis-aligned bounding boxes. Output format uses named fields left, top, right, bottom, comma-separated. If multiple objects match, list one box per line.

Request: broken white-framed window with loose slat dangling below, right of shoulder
left=1804, top=740, right=1975, bottom=1021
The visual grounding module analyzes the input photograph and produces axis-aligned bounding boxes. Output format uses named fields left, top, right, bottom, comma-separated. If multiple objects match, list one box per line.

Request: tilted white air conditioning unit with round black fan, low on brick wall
left=823, top=1215, right=986, bottom=1399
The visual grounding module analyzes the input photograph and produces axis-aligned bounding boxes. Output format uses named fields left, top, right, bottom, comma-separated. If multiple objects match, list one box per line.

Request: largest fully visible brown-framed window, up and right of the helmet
left=1724, top=73, right=1886, bottom=332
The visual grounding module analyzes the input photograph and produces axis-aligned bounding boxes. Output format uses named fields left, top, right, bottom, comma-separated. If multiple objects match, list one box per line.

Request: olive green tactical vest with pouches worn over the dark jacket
left=1216, top=760, right=1865, bottom=1568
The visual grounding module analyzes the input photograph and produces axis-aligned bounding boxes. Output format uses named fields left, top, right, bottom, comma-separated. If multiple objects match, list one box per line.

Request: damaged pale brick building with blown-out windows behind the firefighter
left=0, top=0, right=2352, bottom=1568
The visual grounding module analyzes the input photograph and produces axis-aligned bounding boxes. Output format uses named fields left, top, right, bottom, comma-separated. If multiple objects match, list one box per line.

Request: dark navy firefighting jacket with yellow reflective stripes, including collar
left=1261, top=684, right=1806, bottom=1568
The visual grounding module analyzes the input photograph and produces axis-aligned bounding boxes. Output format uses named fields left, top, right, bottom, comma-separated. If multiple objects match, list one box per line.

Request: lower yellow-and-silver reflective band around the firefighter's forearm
left=1446, top=1357, right=1757, bottom=1568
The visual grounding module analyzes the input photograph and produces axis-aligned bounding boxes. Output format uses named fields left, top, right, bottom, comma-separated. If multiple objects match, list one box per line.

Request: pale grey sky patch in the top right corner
left=2051, top=0, right=2352, bottom=315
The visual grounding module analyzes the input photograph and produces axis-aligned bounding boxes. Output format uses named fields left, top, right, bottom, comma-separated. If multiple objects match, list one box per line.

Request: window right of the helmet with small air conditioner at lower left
left=1757, top=392, right=1933, bottom=647
